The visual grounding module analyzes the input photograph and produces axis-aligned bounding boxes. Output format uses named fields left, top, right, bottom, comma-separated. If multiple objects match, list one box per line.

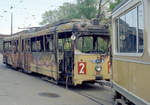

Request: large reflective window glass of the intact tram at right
left=116, top=5, right=143, bottom=53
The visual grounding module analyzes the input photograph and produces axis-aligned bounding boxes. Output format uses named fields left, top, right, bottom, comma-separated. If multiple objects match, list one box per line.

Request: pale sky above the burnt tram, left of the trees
left=0, top=0, right=75, bottom=34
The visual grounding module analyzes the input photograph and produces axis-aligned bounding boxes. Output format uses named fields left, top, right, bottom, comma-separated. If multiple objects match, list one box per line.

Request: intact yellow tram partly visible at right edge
left=112, top=0, right=150, bottom=105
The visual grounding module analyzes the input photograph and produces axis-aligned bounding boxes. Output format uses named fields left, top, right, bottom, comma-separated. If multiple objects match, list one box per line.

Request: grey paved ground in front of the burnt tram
left=0, top=55, right=113, bottom=105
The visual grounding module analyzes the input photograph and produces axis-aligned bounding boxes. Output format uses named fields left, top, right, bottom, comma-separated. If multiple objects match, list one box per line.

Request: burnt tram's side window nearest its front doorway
left=45, top=35, right=53, bottom=52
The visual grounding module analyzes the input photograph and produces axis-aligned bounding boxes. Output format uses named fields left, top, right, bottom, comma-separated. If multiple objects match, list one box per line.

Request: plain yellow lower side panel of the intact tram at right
left=113, top=60, right=150, bottom=102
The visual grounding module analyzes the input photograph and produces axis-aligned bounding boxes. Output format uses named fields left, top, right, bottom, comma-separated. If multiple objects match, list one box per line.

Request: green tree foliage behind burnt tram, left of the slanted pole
left=40, top=0, right=98, bottom=25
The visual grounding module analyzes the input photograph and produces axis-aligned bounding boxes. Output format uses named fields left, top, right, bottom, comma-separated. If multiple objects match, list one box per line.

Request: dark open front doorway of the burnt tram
left=58, top=34, right=74, bottom=80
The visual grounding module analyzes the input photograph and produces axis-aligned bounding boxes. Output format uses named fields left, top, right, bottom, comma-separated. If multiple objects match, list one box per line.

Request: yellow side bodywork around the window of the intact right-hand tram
left=113, top=0, right=150, bottom=105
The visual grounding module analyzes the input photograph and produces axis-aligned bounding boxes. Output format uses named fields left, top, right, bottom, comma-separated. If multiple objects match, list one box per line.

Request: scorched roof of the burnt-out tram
left=3, top=19, right=109, bottom=40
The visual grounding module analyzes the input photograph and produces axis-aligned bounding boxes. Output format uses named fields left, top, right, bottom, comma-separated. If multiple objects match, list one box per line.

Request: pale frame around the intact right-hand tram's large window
left=115, top=3, right=144, bottom=56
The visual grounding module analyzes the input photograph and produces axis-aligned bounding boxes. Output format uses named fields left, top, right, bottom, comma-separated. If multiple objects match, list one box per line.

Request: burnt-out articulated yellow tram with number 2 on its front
left=3, top=19, right=110, bottom=85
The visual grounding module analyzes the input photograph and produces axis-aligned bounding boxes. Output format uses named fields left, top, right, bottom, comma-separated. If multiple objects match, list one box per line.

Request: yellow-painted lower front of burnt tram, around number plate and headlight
left=73, top=54, right=110, bottom=85
